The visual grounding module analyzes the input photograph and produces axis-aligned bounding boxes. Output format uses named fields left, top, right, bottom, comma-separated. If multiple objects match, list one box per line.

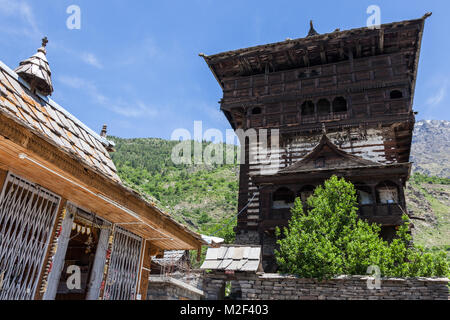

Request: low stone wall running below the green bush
left=203, top=272, right=449, bottom=300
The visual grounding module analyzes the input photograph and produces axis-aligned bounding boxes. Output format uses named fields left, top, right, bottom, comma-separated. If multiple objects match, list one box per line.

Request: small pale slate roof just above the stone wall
left=200, top=245, right=262, bottom=272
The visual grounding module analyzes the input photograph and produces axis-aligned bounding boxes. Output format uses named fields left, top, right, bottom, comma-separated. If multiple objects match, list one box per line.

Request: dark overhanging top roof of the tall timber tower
left=200, top=13, right=431, bottom=88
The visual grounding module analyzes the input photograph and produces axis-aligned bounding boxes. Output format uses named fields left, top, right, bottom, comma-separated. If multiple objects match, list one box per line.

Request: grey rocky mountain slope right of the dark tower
left=410, top=120, right=450, bottom=178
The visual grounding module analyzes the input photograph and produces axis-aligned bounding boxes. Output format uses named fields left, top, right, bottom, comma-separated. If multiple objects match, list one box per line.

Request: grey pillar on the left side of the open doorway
left=42, top=202, right=75, bottom=300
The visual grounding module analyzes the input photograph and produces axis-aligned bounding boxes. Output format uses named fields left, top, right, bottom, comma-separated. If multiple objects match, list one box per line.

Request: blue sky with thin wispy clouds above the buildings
left=0, top=0, right=450, bottom=138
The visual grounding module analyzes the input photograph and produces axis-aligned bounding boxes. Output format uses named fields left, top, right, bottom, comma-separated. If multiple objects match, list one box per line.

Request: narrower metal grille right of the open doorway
left=103, top=227, right=142, bottom=300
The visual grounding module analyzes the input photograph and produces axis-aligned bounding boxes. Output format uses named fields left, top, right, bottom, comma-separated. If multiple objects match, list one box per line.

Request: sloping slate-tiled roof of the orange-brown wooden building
left=0, top=61, right=120, bottom=182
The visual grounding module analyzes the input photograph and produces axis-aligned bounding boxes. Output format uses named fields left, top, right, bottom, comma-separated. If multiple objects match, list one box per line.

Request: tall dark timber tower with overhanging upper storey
left=200, top=13, right=431, bottom=272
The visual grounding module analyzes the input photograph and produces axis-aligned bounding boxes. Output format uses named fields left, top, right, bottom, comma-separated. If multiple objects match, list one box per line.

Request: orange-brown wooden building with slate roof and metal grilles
left=0, top=38, right=203, bottom=300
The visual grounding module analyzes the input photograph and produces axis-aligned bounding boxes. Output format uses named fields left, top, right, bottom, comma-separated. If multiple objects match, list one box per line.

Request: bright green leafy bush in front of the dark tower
left=275, top=176, right=449, bottom=279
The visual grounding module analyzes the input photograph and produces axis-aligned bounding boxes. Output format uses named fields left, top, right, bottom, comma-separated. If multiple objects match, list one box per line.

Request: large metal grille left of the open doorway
left=0, top=173, right=60, bottom=300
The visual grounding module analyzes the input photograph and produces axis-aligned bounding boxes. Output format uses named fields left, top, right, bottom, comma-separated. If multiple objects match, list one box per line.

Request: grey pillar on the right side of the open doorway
left=86, top=228, right=111, bottom=300
